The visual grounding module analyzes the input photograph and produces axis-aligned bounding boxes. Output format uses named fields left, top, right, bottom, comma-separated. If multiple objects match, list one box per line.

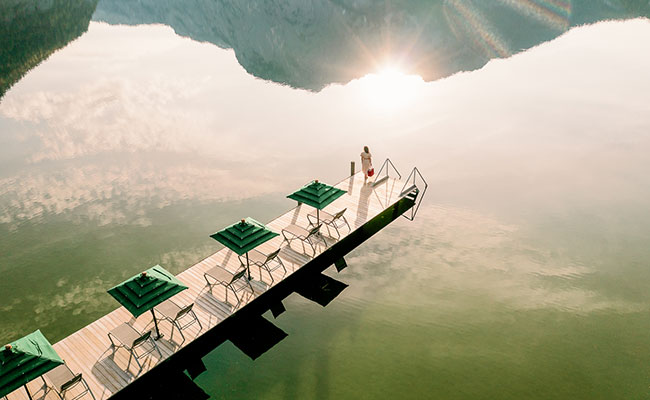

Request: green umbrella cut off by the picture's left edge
left=0, top=330, right=63, bottom=399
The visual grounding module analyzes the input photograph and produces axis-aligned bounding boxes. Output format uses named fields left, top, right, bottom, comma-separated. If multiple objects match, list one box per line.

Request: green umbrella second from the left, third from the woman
left=108, top=265, right=187, bottom=340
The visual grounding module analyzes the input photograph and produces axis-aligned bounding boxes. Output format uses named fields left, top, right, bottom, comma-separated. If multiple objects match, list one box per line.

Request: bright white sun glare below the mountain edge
left=359, top=68, right=424, bottom=110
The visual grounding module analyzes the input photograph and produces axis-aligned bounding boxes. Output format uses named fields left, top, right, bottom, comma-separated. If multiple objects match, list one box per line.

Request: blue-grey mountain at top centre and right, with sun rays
left=93, top=0, right=650, bottom=90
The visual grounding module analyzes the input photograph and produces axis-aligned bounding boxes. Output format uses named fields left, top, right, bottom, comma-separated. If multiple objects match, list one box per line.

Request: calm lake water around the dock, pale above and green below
left=0, top=1, right=650, bottom=399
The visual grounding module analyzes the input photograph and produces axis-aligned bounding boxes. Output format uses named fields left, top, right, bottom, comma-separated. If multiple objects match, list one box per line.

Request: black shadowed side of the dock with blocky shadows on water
left=113, top=193, right=414, bottom=399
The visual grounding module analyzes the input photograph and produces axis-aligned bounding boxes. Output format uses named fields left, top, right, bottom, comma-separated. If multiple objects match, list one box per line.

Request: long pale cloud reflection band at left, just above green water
left=0, top=160, right=277, bottom=226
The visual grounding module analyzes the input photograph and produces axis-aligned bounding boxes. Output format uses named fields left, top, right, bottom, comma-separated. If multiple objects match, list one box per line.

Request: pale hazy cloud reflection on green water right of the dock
left=348, top=206, right=648, bottom=315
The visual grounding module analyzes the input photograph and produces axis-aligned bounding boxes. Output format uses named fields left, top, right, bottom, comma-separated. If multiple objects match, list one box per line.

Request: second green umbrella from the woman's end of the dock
left=210, top=217, right=279, bottom=280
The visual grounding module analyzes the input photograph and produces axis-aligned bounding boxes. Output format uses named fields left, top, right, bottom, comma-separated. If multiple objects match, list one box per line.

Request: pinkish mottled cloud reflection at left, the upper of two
left=0, top=78, right=237, bottom=163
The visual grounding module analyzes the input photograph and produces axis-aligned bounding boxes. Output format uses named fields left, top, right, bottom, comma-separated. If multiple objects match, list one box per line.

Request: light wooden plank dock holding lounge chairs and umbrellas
left=7, top=173, right=415, bottom=400
